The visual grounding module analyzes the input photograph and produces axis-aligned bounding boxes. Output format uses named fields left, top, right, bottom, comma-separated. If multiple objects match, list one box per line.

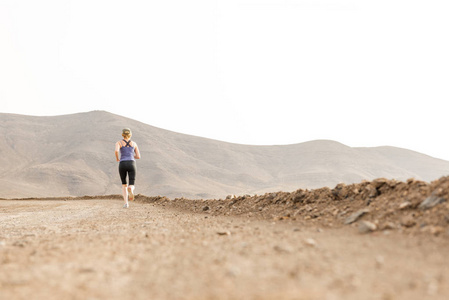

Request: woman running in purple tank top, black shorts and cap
left=115, top=128, right=140, bottom=208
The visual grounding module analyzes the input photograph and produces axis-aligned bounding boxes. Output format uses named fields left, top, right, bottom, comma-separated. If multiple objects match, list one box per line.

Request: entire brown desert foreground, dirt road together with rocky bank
left=0, top=177, right=449, bottom=300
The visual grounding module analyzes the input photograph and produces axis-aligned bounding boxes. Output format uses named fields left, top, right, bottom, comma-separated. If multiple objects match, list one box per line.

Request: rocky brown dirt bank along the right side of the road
left=136, top=177, right=449, bottom=236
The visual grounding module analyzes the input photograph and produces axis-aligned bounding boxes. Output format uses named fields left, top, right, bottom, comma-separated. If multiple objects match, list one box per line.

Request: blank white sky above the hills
left=0, top=0, right=449, bottom=160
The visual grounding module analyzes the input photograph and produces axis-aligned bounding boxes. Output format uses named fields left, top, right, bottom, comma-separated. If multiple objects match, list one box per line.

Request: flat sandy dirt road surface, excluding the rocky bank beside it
left=0, top=199, right=449, bottom=300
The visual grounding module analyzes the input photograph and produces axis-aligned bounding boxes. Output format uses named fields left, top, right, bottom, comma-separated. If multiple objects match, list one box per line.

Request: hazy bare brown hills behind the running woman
left=0, top=111, right=449, bottom=198
